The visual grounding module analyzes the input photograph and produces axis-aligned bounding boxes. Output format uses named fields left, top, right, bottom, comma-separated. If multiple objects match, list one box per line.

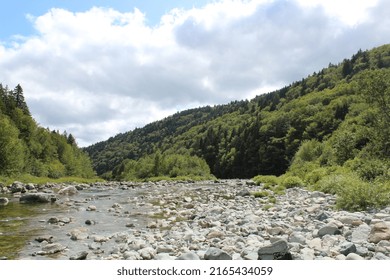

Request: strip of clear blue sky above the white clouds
left=0, top=0, right=212, bottom=41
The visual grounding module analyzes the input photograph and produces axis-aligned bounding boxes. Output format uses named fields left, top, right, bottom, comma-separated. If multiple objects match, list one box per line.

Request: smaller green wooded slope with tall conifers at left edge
left=0, top=84, right=95, bottom=178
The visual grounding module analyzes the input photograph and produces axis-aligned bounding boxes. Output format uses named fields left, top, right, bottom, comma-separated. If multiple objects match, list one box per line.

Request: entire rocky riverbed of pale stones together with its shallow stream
left=0, top=180, right=390, bottom=260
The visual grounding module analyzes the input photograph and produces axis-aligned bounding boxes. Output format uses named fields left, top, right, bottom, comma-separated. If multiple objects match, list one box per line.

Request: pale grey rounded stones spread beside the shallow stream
left=1, top=180, right=390, bottom=260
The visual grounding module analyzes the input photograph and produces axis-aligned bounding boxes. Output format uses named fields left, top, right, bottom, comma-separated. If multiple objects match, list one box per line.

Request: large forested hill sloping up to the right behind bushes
left=86, top=45, right=390, bottom=179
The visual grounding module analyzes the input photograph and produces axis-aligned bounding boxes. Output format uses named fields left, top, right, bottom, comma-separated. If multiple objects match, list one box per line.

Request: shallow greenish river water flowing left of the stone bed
left=0, top=188, right=152, bottom=259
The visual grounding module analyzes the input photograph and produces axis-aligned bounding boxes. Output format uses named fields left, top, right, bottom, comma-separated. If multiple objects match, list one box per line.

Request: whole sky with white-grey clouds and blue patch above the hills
left=0, top=0, right=390, bottom=146
